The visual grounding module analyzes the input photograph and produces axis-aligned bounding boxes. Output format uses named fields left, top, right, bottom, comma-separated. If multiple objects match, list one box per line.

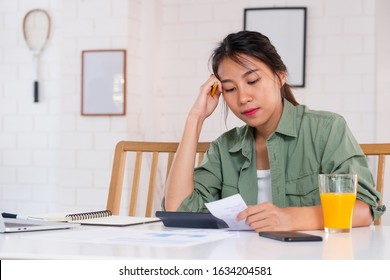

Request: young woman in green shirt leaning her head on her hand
left=163, top=31, right=384, bottom=232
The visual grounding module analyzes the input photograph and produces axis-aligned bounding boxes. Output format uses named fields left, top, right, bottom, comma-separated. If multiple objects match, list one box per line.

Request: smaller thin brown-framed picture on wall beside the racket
left=81, top=50, right=126, bottom=116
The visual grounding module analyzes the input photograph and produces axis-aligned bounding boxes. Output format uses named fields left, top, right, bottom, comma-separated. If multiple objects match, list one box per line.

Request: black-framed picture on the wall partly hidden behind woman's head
left=244, top=7, right=306, bottom=87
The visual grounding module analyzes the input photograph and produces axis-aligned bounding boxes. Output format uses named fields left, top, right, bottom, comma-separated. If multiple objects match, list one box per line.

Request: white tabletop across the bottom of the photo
left=0, top=222, right=390, bottom=260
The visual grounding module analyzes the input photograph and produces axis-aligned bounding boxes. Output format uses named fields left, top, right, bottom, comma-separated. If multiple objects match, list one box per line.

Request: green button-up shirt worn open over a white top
left=172, top=100, right=385, bottom=219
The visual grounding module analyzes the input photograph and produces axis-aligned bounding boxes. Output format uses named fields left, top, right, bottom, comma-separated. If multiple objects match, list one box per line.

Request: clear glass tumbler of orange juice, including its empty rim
left=318, top=174, right=358, bottom=233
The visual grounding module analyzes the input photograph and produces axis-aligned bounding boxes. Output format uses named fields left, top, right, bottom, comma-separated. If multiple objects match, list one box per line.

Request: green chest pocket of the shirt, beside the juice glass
left=286, top=172, right=321, bottom=207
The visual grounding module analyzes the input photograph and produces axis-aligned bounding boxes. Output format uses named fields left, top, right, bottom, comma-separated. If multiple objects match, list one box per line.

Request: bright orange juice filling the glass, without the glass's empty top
left=320, top=193, right=356, bottom=230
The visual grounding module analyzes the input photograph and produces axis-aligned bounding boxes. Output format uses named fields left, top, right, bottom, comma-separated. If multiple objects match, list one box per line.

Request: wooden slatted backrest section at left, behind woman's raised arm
left=107, top=141, right=210, bottom=217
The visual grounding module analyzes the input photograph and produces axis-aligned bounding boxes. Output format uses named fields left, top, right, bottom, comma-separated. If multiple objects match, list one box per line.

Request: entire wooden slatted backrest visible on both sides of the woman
left=107, top=141, right=390, bottom=222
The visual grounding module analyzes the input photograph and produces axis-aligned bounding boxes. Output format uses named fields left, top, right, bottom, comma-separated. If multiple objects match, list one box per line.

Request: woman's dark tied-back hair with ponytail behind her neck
left=210, top=31, right=299, bottom=105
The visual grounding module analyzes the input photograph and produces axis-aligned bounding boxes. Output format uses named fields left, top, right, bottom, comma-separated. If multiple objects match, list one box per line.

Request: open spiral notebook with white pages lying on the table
left=31, top=210, right=160, bottom=226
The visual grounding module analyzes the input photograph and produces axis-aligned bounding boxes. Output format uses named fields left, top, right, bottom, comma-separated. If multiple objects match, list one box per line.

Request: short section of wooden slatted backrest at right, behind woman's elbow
left=360, top=143, right=390, bottom=225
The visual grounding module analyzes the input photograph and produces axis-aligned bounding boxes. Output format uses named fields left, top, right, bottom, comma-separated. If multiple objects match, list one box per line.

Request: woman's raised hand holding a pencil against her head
left=189, top=74, right=222, bottom=120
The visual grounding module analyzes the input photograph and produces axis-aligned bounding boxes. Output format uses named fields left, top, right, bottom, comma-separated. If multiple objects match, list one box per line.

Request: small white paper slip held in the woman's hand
left=205, top=194, right=253, bottom=230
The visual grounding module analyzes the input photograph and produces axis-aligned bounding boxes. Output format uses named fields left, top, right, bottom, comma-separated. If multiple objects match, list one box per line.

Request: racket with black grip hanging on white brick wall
left=23, top=9, right=51, bottom=102
